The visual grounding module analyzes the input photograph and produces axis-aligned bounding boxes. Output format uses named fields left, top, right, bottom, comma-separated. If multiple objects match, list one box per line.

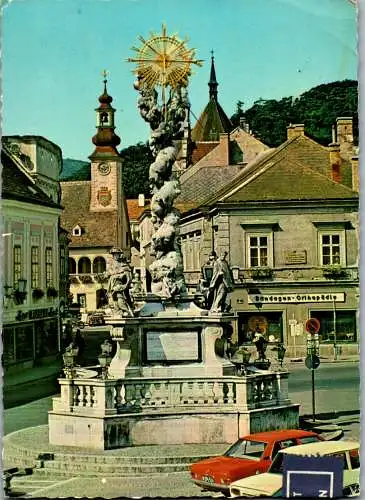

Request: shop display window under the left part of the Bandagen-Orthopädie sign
left=238, top=311, right=283, bottom=344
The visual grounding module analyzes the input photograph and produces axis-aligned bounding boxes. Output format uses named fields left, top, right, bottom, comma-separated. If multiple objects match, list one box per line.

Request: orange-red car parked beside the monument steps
left=190, top=429, right=323, bottom=496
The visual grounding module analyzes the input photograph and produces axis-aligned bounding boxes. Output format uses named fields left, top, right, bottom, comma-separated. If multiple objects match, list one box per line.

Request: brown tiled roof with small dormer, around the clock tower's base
left=60, top=181, right=118, bottom=248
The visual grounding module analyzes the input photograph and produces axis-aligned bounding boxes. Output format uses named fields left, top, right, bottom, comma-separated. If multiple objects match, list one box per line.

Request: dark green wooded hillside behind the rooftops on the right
left=231, top=80, right=358, bottom=147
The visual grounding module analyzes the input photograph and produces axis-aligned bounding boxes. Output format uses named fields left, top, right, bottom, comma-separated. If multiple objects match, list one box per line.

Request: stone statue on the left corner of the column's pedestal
left=107, top=248, right=134, bottom=316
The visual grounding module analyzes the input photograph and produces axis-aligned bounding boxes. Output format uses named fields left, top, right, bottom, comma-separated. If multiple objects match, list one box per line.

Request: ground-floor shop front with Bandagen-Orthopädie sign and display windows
left=232, top=287, right=359, bottom=357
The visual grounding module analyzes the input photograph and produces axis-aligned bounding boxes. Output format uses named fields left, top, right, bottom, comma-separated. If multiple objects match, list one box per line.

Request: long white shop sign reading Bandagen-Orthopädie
left=248, top=292, right=345, bottom=304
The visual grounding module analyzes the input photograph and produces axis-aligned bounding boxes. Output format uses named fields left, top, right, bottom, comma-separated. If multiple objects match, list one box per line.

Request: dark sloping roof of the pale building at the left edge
left=1, top=148, right=61, bottom=208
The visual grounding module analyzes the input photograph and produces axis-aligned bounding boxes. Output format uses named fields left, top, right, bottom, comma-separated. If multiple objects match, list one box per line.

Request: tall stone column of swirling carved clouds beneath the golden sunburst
left=134, top=81, right=190, bottom=299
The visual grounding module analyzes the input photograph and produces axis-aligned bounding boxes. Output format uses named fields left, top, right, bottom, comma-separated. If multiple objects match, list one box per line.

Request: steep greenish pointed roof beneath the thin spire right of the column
left=191, top=99, right=233, bottom=142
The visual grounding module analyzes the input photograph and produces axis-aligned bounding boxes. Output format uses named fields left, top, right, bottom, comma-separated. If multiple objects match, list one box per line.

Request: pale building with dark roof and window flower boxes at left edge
left=1, top=136, right=67, bottom=374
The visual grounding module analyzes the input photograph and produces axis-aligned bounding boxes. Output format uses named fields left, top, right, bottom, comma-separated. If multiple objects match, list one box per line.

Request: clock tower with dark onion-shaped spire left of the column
left=89, top=72, right=130, bottom=254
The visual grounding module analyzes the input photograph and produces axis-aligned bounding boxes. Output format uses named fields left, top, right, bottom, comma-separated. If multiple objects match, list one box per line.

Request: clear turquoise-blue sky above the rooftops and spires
left=2, top=0, right=357, bottom=160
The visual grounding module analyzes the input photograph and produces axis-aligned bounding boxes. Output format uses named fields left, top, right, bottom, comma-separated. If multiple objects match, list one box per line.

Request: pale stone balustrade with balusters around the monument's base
left=53, top=371, right=290, bottom=417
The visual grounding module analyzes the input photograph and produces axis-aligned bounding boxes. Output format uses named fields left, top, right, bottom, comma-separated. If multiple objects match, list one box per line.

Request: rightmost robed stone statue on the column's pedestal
left=209, top=252, right=233, bottom=312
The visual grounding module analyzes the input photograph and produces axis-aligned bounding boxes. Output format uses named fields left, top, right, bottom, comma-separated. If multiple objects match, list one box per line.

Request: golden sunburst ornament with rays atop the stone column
left=127, top=25, right=203, bottom=89
